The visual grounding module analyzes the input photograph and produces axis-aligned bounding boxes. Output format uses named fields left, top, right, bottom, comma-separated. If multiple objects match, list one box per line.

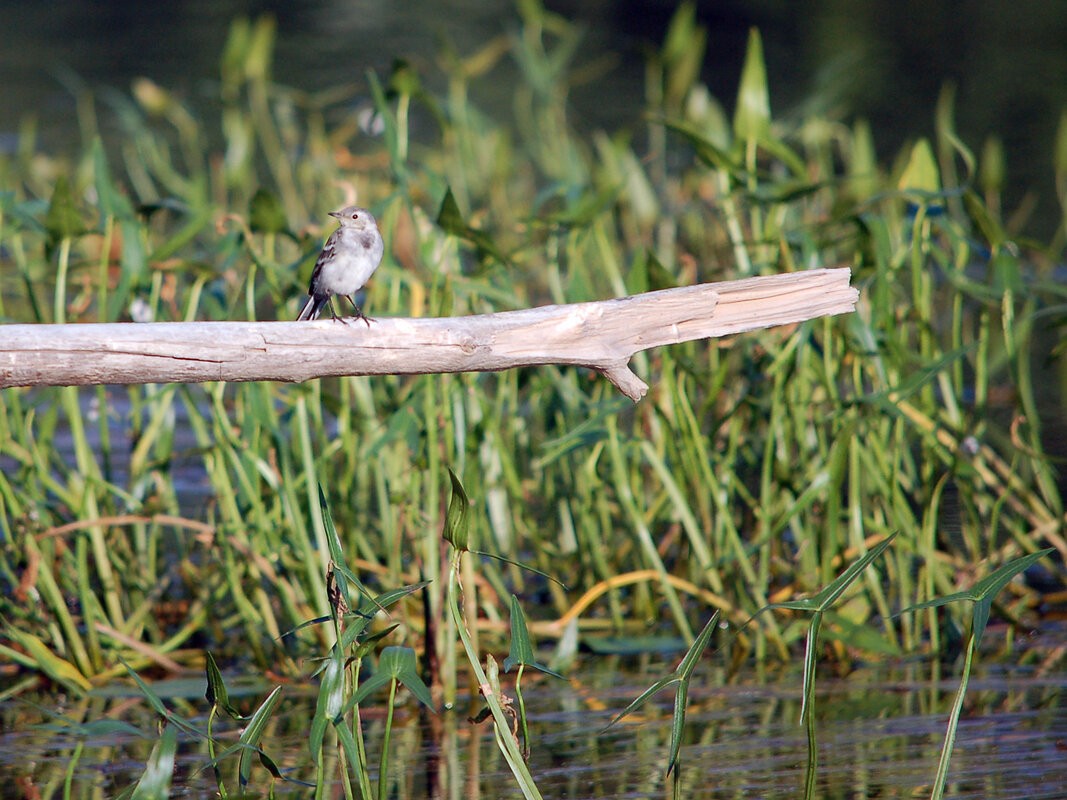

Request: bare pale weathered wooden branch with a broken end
left=0, top=269, right=858, bottom=401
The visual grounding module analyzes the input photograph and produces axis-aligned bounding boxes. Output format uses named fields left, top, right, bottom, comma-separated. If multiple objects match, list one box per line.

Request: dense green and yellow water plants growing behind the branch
left=0, top=3, right=1067, bottom=798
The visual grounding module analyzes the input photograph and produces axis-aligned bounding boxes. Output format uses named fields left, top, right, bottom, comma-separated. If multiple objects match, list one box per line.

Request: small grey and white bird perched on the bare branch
left=297, top=206, right=385, bottom=327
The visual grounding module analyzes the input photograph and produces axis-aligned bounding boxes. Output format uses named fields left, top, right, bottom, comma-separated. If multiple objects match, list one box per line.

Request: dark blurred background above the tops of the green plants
left=0, top=0, right=1067, bottom=235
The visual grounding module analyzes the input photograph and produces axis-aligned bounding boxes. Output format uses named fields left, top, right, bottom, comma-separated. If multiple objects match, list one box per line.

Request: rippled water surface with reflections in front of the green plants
left=0, top=624, right=1067, bottom=800
